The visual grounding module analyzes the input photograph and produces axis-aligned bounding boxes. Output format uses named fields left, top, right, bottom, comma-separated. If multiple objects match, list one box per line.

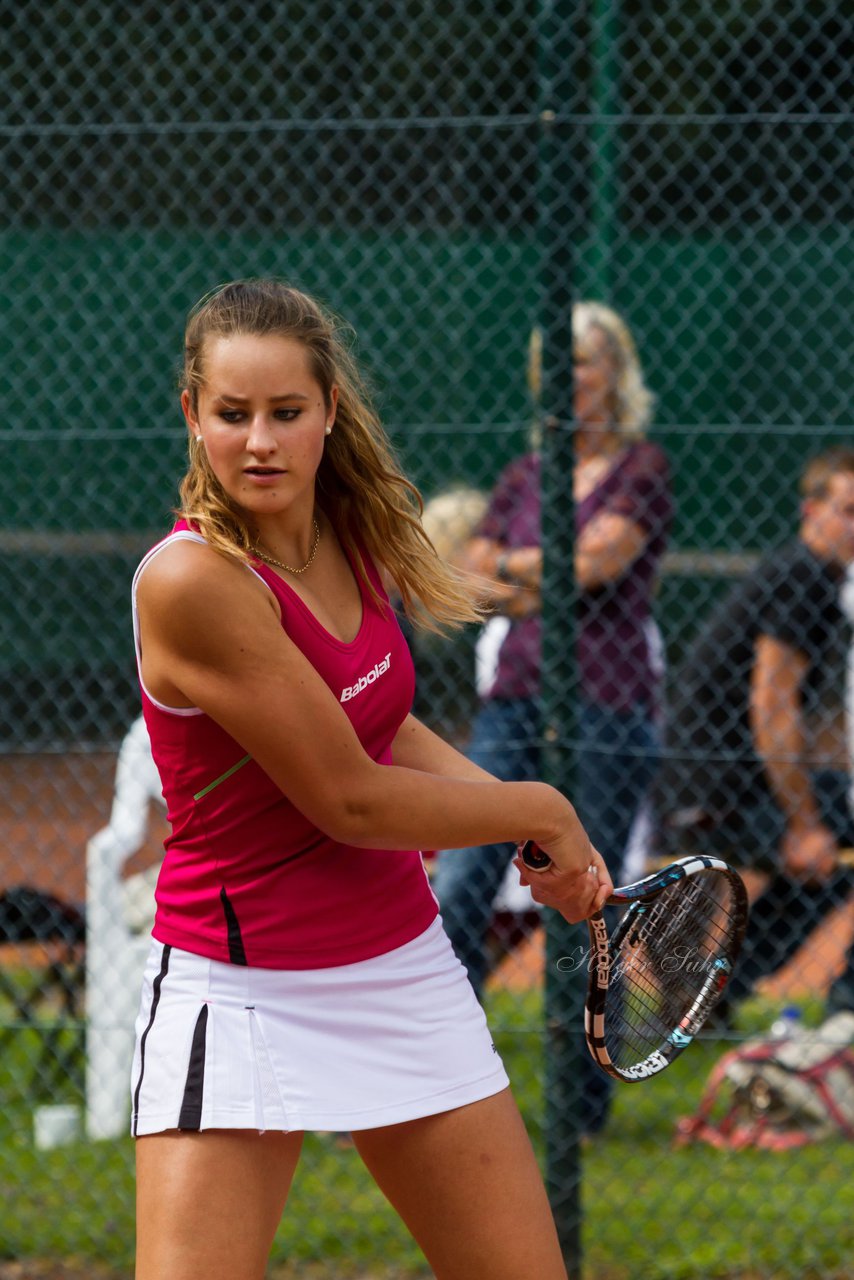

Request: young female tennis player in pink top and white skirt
left=132, top=280, right=612, bottom=1280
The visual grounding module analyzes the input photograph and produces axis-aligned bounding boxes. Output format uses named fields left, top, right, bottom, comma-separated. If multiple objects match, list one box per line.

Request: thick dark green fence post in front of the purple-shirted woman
left=538, top=0, right=583, bottom=1280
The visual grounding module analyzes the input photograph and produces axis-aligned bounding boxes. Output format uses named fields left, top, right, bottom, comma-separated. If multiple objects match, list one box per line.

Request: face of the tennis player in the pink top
left=182, top=334, right=338, bottom=516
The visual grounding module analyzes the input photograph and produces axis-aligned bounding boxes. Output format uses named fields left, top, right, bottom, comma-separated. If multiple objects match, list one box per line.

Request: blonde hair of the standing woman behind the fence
left=528, top=302, right=656, bottom=436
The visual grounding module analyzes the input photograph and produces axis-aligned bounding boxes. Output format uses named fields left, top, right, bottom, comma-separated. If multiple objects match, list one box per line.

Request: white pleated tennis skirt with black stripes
left=131, top=918, right=508, bottom=1137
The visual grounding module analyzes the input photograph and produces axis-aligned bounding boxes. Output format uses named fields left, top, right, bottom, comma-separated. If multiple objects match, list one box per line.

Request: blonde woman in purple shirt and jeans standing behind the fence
left=434, top=302, right=672, bottom=1133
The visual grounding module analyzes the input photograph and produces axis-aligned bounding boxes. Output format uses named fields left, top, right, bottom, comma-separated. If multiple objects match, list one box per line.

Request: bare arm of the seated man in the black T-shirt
left=750, top=635, right=836, bottom=877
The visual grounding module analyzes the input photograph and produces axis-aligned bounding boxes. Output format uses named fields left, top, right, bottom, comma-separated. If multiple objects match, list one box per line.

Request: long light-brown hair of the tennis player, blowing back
left=179, top=279, right=480, bottom=631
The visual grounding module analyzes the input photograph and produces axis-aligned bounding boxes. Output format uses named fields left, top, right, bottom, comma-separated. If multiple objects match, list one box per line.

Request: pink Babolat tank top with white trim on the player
left=133, top=521, right=438, bottom=969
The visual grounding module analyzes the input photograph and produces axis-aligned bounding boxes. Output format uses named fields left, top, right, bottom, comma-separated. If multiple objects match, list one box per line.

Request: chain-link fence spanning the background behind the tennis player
left=0, top=0, right=854, bottom=1280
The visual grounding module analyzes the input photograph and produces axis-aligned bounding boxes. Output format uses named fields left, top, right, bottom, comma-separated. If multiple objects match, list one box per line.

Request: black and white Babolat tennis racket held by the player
left=521, top=841, right=748, bottom=1080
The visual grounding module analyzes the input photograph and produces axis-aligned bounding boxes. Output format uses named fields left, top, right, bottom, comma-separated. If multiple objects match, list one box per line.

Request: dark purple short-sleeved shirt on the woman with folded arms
left=478, top=440, right=672, bottom=709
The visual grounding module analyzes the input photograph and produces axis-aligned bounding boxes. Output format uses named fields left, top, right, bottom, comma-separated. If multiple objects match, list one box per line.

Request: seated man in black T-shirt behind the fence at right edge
left=656, top=448, right=854, bottom=1010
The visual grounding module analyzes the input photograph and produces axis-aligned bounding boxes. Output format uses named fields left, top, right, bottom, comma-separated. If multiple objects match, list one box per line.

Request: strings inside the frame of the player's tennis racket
left=604, top=873, right=737, bottom=1069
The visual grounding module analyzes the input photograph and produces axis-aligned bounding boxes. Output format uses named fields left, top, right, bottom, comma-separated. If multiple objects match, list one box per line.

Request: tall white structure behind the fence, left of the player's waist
left=86, top=717, right=163, bottom=1138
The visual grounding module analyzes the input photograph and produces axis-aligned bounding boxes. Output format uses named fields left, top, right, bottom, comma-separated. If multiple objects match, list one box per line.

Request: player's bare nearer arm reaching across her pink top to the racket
left=138, top=543, right=607, bottom=919
